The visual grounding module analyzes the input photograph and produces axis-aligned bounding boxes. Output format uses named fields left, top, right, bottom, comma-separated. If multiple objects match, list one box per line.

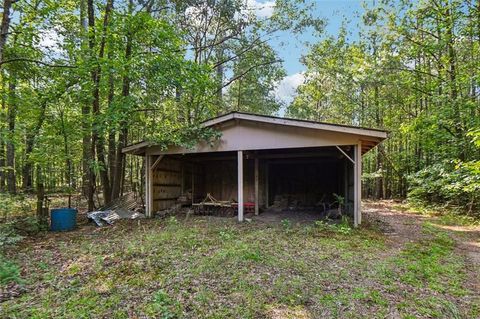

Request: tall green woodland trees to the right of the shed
left=287, top=0, right=480, bottom=216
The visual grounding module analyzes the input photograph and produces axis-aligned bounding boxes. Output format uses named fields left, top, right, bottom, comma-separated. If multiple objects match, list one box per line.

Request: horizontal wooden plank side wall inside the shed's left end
left=153, top=156, right=182, bottom=212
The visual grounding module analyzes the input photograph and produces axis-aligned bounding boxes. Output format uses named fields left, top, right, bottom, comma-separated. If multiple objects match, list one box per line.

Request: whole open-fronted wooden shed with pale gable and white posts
left=123, top=112, right=387, bottom=226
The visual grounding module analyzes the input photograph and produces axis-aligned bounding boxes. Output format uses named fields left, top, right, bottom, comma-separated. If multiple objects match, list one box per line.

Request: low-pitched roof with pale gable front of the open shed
left=123, top=112, right=388, bottom=156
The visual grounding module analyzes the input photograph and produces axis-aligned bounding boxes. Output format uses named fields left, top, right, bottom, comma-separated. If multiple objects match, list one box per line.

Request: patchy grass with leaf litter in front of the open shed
left=0, top=218, right=478, bottom=318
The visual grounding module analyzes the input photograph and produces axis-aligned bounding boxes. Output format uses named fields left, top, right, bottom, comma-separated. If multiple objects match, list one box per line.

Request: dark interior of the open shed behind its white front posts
left=153, top=146, right=354, bottom=220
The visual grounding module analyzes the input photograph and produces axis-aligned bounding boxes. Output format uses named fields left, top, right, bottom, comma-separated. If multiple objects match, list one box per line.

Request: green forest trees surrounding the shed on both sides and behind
left=0, top=0, right=480, bottom=218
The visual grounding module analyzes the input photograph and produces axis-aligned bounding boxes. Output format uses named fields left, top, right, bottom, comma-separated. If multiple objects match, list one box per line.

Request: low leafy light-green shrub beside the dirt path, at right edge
left=408, top=161, right=480, bottom=213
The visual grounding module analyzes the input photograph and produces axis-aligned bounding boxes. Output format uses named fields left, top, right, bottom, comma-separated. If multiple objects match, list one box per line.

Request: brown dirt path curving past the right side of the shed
left=363, top=201, right=480, bottom=295
